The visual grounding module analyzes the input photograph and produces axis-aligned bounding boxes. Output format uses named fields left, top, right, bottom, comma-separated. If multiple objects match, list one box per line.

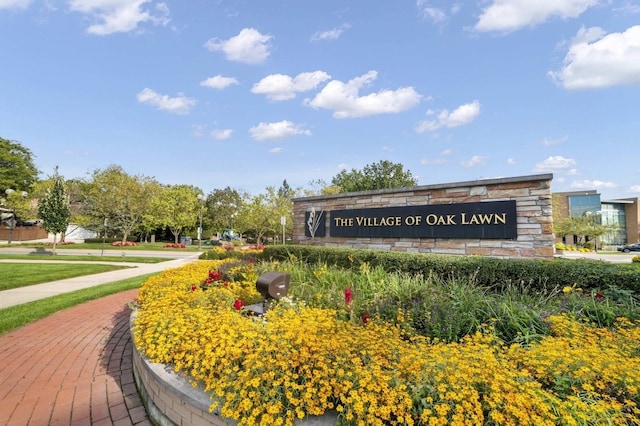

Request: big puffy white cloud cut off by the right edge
left=549, top=25, right=640, bottom=89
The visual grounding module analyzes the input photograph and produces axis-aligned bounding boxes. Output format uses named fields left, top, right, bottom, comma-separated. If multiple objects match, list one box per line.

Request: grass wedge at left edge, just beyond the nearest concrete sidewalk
left=0, top=263, right=127, bottom=290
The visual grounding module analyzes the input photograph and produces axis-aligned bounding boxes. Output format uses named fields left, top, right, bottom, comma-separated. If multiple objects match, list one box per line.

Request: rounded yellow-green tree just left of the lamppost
left=154, top=185, right=200, bottom=243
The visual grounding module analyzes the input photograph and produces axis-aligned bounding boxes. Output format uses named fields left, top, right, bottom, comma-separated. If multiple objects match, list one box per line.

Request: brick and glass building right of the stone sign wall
left=553, top=190, right=640, bottom=249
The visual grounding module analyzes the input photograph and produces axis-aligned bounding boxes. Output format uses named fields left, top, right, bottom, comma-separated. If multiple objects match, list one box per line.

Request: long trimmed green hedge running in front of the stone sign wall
left=261, top=245, right=640, bottom=294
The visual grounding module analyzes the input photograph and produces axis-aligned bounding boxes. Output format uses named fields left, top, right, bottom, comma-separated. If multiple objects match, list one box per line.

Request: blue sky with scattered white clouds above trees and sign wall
left=0, top=0, right=640, bottom=199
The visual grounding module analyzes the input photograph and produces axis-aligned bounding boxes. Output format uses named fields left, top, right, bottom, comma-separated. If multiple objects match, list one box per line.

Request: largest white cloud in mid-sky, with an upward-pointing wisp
left=305, top=71, right=422, bottom=118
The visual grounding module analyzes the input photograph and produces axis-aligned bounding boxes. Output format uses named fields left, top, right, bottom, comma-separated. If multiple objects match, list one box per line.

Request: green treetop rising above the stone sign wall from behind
left=331, top=160, right=418, bottom=192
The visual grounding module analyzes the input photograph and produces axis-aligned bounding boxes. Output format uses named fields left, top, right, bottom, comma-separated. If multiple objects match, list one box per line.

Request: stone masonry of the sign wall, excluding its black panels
left=293, top=174, right=554, bottom=259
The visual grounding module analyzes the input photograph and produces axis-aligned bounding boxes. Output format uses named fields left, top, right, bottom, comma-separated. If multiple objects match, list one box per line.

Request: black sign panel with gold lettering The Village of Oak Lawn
left=329, top=200, right=518, bottom=240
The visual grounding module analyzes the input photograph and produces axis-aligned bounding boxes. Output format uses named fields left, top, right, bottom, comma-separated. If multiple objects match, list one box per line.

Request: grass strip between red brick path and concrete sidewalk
left=0, top=274, right=151, bottom=334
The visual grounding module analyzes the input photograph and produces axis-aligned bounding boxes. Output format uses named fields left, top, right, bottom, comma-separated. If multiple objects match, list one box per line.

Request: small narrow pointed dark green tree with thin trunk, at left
left=38, top=167, right=71, bottom=254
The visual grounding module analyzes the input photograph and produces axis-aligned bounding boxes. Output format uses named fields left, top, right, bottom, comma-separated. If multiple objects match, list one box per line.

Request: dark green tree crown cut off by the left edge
left=0, top=138, right=39, bottom=192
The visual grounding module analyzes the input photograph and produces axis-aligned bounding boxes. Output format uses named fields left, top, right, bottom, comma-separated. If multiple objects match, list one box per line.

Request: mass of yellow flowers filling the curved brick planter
left=133, top=260, right=640, bottom=425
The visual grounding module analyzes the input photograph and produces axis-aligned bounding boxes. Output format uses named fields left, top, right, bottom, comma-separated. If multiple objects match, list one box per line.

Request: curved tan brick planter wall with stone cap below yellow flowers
left=130, top=312, right=337, bottom=426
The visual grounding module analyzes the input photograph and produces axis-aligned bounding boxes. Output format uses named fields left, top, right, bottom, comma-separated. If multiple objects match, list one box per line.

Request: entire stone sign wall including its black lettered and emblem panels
left=293, top=174, right=554, bottom=258
